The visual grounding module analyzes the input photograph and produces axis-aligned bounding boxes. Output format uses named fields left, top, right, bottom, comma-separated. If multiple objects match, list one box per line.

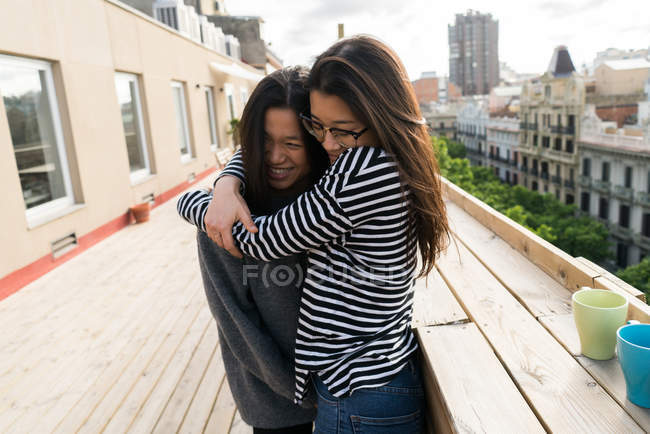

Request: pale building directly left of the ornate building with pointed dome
left=485, top=116, right=519, bottom=185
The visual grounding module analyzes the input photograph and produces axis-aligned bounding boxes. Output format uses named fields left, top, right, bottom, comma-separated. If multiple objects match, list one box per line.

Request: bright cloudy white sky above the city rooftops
left=226, top=0, right=650, bottom=80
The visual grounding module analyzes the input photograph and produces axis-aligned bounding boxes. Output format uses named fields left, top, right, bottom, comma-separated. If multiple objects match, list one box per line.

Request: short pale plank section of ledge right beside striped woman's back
left=412, top=269, right=468, bottom=328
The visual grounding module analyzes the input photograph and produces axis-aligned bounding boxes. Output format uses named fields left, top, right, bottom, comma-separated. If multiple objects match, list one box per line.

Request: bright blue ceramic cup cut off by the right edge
left=616, top=321, right=650, bottom=408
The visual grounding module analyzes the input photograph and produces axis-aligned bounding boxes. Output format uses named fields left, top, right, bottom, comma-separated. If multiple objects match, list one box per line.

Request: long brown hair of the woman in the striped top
left=309, top=36, right=450, bottom=276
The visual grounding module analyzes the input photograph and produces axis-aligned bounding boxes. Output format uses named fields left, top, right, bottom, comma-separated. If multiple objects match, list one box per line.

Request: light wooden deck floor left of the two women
left=0, top=176, right=252, bottom=433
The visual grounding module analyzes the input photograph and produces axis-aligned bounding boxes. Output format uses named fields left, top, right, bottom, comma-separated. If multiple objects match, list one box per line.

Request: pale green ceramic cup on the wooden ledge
left=571, top=286, right=628, bottom=360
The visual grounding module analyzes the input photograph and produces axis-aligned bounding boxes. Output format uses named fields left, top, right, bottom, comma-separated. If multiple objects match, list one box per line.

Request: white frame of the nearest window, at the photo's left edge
left=0, top=54, right=75, bottom=228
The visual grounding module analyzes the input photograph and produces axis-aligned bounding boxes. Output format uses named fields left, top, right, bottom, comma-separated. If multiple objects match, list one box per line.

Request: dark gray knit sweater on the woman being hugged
left=191, top=209, right=316, bottom=428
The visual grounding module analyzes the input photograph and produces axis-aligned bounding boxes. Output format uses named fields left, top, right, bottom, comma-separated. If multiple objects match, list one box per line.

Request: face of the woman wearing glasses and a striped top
left=309, top=90, right=377, bottom=163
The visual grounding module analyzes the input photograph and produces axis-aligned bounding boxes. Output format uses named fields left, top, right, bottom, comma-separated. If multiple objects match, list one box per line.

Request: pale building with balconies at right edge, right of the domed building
left=578, top=105, right=650, bottom=269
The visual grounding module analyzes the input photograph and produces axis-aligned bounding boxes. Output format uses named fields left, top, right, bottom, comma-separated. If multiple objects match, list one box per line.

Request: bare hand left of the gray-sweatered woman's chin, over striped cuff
left=203, top=176, right=257, bottom=258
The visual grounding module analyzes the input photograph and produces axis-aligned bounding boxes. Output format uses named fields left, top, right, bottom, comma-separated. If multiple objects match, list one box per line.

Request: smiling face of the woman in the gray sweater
left=264, top=107, right=311, bottom=190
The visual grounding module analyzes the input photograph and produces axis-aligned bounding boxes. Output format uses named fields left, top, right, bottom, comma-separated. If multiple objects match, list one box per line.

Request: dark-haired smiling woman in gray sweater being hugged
left=177, top=67, right=328, bottom=433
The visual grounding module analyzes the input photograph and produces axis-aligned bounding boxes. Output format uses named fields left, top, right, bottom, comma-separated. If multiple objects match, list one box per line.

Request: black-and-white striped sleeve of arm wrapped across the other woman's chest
left=233, top=146, right=399, bottom=261
